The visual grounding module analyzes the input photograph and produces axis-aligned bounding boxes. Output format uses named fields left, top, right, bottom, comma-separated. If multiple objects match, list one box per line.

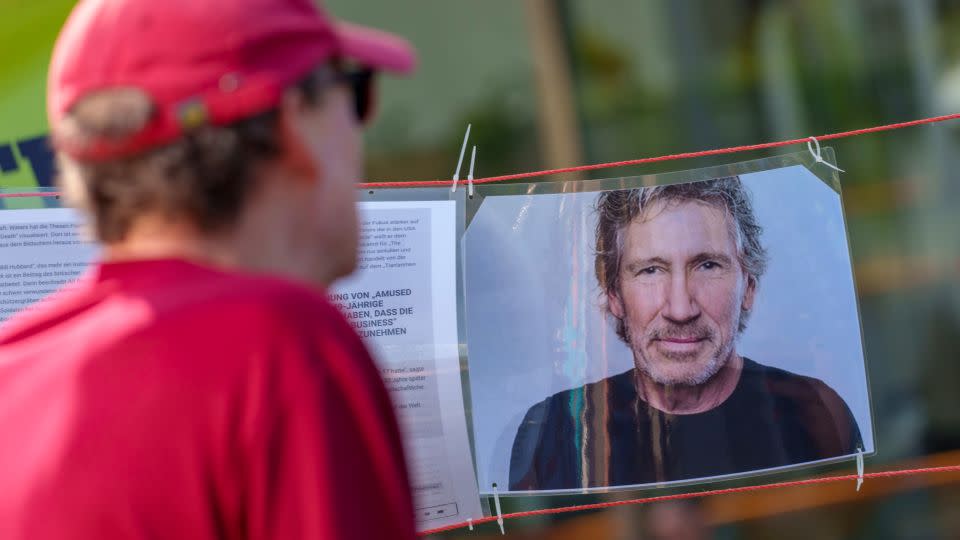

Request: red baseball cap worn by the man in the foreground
left=47, top=0, right=416, bottom=160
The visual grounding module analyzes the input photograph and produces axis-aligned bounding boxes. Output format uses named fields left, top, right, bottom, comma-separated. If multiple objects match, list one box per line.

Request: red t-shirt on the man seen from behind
left=0, top=260, right=415, bottom=540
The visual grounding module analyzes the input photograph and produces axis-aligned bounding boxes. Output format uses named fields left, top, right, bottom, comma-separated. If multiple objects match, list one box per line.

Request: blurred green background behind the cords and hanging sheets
left=0, top=0, right=960, bottom=539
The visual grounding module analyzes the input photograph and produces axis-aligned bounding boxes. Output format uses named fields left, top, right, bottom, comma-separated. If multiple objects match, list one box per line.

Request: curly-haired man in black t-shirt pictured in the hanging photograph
left=509, top=176, right=863, bottom=491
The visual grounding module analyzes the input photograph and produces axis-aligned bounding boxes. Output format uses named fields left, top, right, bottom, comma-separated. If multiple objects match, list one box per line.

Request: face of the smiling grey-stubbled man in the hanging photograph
left=608, top=201, right=756, bottom=386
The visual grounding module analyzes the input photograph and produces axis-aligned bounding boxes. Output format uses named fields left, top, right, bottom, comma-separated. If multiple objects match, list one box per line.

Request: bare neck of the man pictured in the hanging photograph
left=634, top=352, right=743, bottom=414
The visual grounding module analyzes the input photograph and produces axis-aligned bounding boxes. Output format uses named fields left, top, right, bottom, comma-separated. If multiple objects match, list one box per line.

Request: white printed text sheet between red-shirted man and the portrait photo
left=332, top=201, right=483, bottom=530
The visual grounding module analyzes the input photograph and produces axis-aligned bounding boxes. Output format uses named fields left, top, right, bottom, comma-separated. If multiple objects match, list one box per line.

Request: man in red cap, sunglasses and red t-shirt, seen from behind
left=0, top=0, right=414, bottom=540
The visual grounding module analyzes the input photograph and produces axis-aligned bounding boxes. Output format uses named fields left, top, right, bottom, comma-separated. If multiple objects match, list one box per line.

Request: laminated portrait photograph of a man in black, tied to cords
left=463, top=156, right=874, bottom=494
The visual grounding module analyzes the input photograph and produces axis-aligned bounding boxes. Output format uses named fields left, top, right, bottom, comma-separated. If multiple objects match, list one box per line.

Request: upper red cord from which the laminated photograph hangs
left=0, top=113, right=960, bottom=199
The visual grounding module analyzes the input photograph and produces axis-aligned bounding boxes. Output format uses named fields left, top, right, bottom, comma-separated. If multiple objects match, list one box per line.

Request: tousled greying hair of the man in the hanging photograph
left=594, top=176, right=767, bottom=341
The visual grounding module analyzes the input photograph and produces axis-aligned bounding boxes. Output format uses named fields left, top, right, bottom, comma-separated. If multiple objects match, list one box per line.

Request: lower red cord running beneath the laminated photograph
left=419, top=465, right=960, bottom=536
